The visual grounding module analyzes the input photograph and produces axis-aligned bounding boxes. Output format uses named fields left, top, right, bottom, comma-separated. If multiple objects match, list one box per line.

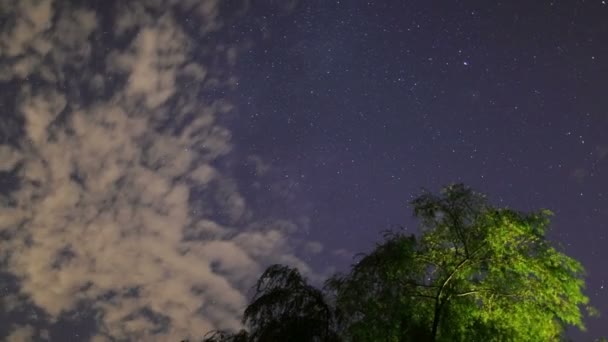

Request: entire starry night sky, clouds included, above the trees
left=0, top=0, right=608, bottom=341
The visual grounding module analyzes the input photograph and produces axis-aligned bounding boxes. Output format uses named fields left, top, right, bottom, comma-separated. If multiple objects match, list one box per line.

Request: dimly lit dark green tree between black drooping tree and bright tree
left=326, top=232, right=430, bottom=341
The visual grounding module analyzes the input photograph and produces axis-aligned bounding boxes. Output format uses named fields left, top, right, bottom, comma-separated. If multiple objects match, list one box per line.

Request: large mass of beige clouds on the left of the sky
left=0, top=1, right=322, bottom=341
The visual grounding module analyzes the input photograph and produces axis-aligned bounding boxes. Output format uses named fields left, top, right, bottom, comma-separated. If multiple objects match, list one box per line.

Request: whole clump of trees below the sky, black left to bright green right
left=198, top=184, right=592, bottom=342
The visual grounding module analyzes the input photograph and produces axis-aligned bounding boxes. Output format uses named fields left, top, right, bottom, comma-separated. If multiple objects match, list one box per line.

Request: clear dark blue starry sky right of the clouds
left=226, top=1, right=608, bottom=338
